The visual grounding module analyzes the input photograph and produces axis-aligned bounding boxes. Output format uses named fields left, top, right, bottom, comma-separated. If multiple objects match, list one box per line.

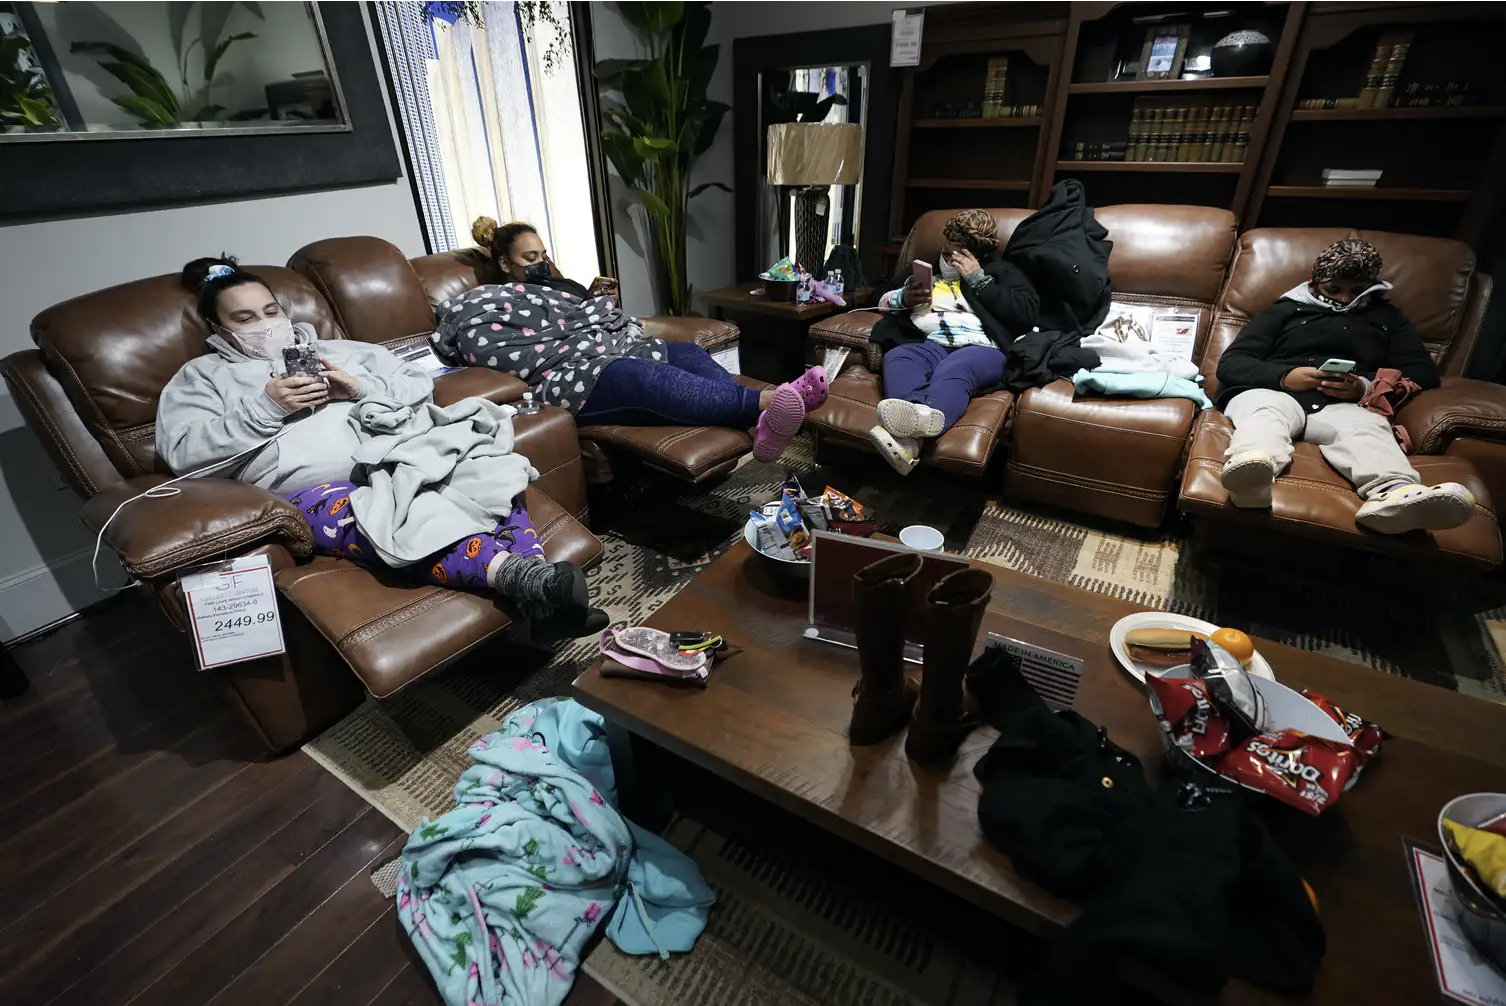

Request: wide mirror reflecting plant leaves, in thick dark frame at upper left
left=0, top=0, right=351, bottom=143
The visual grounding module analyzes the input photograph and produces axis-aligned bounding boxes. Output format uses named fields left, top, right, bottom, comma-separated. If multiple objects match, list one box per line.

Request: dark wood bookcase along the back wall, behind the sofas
left=890, top=0, right=1506, bottom=241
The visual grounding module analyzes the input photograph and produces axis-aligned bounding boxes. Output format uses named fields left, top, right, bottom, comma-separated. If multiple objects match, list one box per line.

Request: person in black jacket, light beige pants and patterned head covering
left=1217, top=238, right=1474, bottom=535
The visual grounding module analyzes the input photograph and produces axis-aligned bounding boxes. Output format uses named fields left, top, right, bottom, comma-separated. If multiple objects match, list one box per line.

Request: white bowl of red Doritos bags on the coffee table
left=1146, top=639, right=1386, bottom=816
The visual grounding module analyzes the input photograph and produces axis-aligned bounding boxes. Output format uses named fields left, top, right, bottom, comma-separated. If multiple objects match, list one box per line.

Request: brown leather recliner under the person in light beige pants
left=1179, top=227, right=1506, bottom=569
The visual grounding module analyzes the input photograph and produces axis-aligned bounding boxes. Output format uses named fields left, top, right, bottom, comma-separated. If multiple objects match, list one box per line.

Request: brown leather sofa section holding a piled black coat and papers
left=810, top=205, right=1236, bottom=527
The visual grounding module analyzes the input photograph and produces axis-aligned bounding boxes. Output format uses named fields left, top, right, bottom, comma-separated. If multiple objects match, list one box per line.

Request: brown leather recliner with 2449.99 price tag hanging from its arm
left=0, top=267, right=602, bottom=751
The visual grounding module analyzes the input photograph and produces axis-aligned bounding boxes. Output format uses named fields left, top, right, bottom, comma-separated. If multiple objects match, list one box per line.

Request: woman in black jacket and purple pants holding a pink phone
left=867, top=209, right=1041, bottom=474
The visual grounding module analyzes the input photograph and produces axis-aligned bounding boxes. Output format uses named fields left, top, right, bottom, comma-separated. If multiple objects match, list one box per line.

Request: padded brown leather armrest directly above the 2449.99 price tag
left=81, top=474, right=313, bottom=581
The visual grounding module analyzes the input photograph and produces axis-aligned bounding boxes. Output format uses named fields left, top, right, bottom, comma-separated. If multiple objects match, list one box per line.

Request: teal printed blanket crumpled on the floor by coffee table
left=398, top=699, right=714, bottom=1006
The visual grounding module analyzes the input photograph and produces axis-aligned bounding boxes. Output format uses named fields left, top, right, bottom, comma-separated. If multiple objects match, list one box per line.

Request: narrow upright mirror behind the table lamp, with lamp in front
left=758, top=63, right=869, bottom=274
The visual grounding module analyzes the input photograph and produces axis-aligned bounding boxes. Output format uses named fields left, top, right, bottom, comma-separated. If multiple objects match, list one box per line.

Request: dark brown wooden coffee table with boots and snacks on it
left=574, top=542, right=1506, bottom=1006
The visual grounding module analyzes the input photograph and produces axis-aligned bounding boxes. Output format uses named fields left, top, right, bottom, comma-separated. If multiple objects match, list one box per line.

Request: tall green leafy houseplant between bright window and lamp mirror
left=596, top=3, right=732, bottom=315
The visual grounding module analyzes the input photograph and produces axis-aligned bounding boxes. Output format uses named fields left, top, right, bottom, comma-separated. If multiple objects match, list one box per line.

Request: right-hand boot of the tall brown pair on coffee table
left=905, top=569, right=994, bottom=762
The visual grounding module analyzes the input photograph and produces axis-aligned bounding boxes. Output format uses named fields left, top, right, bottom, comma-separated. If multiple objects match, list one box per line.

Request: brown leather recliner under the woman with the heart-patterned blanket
left=288, top=238, right=767, bottom=483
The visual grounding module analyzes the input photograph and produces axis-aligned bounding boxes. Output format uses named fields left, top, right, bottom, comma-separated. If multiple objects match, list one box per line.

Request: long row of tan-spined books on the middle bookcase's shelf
left=1096, top=98, right=1256, bottom=163
